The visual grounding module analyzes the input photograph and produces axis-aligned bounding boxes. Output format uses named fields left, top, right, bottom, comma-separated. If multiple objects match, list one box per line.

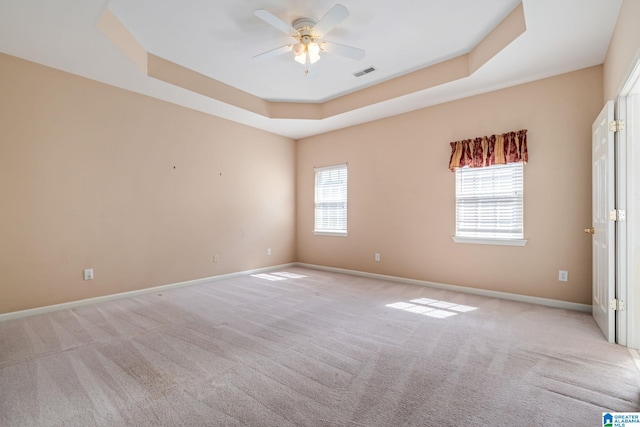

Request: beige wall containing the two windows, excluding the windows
left=297, top=66, right=603, bottom=304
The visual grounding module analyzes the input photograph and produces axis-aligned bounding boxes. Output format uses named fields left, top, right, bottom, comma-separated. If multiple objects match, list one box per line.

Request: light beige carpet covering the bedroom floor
left=0, top=268, right=640, bottom=426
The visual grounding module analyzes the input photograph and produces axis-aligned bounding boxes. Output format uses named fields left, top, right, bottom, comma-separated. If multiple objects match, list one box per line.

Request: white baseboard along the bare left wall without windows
left=0, top=263, right=296, bottom=322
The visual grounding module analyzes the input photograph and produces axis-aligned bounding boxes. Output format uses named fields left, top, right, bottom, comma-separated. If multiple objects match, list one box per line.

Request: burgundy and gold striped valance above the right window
left=449, top=129, right=529, bottom=171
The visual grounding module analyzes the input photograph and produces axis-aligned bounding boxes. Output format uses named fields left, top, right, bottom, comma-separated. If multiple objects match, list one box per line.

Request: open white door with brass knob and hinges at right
left=585, top=101, right=616, bottom=342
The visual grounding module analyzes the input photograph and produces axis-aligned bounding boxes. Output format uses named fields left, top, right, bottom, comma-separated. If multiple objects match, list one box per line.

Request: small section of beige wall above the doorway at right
left=604, top=0, right=640, bottom=101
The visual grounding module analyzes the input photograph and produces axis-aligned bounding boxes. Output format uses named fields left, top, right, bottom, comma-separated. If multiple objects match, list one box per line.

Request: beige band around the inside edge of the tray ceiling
left=97, top=2, right=526, bottom=120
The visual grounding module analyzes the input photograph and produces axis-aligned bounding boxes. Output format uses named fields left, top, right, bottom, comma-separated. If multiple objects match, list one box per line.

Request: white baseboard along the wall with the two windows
left=295, top=262, right=591, bottom=313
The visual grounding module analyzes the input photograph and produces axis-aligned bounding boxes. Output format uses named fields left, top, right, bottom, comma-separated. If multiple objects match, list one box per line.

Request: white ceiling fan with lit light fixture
left=253, top=4, right=365, bottom=76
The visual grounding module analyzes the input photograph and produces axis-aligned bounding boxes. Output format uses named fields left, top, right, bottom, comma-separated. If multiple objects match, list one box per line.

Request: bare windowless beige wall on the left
left=0, top=55, right=295, bottom=313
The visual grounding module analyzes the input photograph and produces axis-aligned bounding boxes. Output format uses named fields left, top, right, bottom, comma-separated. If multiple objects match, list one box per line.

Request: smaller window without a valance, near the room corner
left=314, top=164, right=347, bottom=235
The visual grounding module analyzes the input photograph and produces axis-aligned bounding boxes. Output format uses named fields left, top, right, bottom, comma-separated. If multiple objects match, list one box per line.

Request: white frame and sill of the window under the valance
left=452, top=163, right=527, bottom=246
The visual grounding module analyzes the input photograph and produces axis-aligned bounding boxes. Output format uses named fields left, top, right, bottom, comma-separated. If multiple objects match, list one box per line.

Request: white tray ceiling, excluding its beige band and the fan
left=0, top=0, right=621, bottom=139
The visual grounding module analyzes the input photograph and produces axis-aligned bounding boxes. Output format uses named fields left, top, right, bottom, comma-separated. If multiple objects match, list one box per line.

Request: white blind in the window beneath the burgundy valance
left=456, top=163, right=523, bottom=239
